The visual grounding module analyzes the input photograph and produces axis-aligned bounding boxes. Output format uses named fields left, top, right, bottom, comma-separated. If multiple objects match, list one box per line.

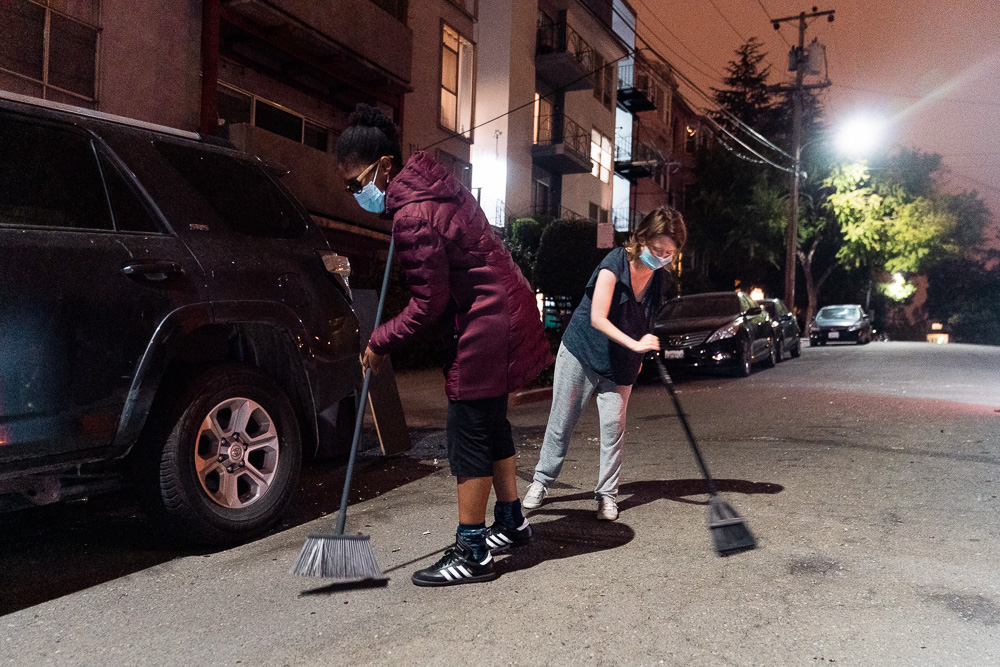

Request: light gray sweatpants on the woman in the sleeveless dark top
left=535, top=345, right=632, bottom=498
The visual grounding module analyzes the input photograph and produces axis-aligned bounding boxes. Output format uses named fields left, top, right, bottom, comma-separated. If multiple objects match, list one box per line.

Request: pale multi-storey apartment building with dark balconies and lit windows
left=472, top=0, right=630, bottom=229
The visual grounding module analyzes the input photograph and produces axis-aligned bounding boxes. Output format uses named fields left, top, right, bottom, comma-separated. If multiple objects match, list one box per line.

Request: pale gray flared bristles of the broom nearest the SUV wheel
left=291, top=535, right=385, bottom=581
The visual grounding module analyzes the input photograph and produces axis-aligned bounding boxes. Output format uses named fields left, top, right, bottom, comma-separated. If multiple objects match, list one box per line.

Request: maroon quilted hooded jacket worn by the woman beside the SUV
left=368, top=152, right=552, bottom=400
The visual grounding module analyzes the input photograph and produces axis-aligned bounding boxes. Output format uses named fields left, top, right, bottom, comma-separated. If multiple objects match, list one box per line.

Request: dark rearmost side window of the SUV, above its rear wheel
left=156, top=142, right=306, bottom=239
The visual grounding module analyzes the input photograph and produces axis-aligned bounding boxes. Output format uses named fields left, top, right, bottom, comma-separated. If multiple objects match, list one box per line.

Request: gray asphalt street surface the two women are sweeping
left=0, top=343, right=1000, bottom=667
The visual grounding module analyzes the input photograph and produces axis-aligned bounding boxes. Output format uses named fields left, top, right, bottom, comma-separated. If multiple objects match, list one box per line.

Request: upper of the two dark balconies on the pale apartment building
left=535, top=21, right=595, bottom=91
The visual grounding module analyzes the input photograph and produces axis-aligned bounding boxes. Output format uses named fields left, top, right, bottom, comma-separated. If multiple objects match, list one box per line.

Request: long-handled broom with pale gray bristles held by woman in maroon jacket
left=291, top=239, right=395, bottom=581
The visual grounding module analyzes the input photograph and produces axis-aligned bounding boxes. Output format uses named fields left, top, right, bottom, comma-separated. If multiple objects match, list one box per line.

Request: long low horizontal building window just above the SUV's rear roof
left=218, top=83, right=330, bottom=153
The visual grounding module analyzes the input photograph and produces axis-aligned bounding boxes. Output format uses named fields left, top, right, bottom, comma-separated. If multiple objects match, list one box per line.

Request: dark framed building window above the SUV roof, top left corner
left=0, top=0, right=99, bottom=101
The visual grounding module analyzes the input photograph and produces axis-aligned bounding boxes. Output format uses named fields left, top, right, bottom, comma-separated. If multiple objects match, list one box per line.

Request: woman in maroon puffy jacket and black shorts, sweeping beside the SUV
left=337, top=104, right=552, bottom=586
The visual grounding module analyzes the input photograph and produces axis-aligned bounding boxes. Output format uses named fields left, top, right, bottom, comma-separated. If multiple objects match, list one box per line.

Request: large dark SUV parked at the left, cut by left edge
left=0, top=93, right=361, bottom=543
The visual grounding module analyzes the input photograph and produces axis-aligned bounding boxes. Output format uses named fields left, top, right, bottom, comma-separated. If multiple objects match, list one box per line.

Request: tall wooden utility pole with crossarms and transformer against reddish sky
left=769, top=7, right=836, bottom=310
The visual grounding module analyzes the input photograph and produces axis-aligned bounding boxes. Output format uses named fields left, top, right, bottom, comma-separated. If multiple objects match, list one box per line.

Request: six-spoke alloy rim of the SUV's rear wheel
left=194, top=397, right=280, bottom=509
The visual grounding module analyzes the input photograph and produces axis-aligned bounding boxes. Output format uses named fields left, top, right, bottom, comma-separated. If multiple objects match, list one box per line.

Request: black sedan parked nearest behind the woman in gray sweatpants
left=654, top=292, right=778, bottom=376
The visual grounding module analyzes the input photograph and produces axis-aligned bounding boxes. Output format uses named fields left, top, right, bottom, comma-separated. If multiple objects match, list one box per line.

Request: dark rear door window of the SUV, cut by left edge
left=0, top=115, right=112, bottom=230
